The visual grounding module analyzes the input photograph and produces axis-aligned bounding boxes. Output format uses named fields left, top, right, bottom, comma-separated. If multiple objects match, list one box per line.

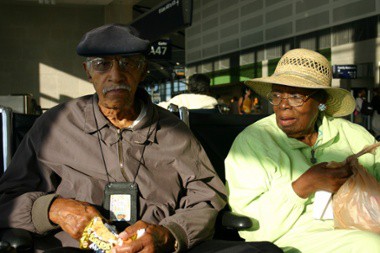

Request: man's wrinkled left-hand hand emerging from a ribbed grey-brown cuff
left=49, top=198, right=101, bottom=239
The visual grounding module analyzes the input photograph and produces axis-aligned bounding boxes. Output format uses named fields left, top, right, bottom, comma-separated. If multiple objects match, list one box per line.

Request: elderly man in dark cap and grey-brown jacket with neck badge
left=0, top=25, right=280, bottom=252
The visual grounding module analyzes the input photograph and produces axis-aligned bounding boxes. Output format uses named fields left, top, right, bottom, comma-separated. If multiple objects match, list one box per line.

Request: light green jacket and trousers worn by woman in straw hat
left=225, top=114, right=380, bottom=253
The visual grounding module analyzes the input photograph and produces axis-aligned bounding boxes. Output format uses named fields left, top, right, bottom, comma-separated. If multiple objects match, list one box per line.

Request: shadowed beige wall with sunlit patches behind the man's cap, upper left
left=0, top=1, right=134, bottom=108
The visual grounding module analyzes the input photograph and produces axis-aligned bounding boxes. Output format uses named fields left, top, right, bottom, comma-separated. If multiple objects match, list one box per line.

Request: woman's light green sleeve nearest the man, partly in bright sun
left=225, top=128, right=307, bottom=241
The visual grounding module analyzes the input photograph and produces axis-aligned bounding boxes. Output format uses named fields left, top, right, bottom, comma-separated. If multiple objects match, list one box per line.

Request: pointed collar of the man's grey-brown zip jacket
left=84, top=87, right=159, bottom=145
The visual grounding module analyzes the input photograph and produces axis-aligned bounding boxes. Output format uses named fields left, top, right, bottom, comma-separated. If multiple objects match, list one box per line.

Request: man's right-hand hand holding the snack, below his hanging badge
left=112, top=221, right=175, bottom=253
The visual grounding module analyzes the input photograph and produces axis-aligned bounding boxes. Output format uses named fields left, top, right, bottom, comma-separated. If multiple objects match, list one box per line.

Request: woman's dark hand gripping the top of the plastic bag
left=292, top=162, right=353, bottom=198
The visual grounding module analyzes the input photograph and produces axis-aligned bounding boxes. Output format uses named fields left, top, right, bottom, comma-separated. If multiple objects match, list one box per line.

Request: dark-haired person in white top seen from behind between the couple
left=158, top=74, right=218, bottom=109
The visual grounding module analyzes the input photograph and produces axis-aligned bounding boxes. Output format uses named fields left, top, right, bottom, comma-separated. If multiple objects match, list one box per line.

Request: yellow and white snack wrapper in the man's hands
left=79, top=217, right=123, bottom=253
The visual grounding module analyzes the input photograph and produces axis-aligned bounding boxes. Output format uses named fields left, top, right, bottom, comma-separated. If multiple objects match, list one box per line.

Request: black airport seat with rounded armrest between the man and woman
left=179, top=107, right=267, bottom=240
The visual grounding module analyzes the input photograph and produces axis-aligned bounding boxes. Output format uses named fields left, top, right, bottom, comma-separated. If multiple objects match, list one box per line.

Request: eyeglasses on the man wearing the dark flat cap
left=86, top=56, right=145, bottom=73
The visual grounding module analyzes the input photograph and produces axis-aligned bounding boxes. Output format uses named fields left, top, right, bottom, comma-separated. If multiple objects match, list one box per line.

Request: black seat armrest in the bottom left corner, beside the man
left=0, top=228, right=34, bottom=252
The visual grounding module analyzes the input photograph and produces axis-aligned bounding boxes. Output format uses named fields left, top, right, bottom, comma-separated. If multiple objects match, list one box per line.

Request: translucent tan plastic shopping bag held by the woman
left=332, top=143, right=380, bottom=233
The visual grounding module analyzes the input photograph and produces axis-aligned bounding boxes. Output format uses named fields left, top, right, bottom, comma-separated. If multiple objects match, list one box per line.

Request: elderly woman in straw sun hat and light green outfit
left=225, top=49, right=380, bottom=253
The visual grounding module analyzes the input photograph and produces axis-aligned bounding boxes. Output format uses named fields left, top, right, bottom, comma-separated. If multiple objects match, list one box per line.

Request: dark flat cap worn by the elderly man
left=77, top=24, right=150, bottom=56
